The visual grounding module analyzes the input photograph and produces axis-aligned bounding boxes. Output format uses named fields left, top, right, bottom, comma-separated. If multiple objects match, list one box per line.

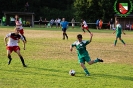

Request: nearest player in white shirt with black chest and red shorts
left=4, top=28, right=27, bottom=67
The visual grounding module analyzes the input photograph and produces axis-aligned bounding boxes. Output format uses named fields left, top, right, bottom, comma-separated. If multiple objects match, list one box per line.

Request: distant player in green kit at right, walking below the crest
left=113, top=20, right=126, bottom=46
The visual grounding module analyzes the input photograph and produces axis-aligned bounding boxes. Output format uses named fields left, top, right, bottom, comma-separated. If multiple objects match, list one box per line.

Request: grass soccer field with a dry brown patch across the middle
left=0, top=27, right=133, bottom=88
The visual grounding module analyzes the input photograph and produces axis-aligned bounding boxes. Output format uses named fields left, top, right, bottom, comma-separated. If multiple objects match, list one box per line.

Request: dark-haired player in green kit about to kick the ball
left=70, top=34, right=103, bottom=76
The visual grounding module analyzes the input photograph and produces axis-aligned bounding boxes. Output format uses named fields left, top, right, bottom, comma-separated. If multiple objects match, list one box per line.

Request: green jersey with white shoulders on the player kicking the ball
left=72, top=40, right=90, bottom=58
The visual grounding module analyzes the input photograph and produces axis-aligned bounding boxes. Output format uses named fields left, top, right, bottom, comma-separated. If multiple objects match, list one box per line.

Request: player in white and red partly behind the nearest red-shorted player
left=15, top=15, right=27, bottom=42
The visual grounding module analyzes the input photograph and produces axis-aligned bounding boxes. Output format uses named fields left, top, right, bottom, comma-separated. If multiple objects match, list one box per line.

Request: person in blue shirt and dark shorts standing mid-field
left=60, top=18, right=68, bottom=40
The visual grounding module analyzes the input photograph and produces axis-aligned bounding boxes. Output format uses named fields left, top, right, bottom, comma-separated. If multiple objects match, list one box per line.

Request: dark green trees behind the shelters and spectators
left=0, top=0, right=132, bottom=23
